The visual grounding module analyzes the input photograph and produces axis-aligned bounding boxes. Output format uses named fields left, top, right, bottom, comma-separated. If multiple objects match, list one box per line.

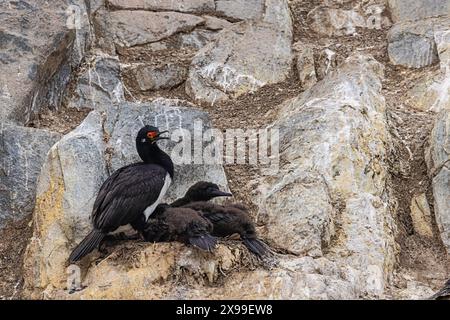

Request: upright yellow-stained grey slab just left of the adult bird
left=25, top=111, right=108, bottom=287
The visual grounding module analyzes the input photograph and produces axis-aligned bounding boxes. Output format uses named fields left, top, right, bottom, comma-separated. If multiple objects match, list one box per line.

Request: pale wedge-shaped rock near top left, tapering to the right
left=98, top=11, right=205, bottom=47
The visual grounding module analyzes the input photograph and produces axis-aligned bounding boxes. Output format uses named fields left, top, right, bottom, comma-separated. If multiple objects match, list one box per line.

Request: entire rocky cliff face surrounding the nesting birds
left=0, top=0, right=450, bottom=299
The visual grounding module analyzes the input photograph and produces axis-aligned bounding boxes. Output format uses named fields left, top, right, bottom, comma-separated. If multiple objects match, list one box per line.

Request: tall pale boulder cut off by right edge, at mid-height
left=427, top=109, right=450, bottom=254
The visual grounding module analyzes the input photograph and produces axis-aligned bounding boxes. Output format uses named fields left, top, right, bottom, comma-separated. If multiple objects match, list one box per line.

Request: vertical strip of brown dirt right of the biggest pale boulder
left=383, top=64, right=450, bottom=289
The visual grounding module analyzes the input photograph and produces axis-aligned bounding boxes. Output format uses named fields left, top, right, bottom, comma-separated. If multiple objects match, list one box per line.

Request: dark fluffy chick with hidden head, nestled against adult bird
left=142, top=204, right=217, bottom=252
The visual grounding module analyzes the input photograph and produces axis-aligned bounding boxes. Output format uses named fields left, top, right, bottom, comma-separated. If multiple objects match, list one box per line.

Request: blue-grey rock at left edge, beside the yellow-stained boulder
left=0, top=123, right=61, bottom=227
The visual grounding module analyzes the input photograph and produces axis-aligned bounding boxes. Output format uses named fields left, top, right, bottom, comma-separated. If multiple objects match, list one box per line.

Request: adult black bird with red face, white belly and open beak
left=69, top=126, right=174, bottom=263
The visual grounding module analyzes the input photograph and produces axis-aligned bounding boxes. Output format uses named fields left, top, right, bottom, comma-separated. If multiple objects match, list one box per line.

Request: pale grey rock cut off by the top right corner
left=388, top=0, right=450, bottom=22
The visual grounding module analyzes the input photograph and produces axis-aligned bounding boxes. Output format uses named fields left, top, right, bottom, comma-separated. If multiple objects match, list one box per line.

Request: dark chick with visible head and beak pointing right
left=171, top=181, right=268, bottom=257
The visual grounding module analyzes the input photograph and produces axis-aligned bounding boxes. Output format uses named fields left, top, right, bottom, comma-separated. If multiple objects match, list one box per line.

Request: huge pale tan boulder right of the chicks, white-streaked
left=255, top=55, right=395, bottom=296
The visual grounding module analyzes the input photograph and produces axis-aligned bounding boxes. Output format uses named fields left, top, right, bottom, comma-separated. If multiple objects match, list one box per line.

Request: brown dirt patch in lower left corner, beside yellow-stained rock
left=0, top=217, right=32, bottom=300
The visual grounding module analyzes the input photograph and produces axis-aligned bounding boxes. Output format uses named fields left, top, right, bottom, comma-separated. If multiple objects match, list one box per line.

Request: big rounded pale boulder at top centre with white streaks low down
left=186, top=0, right=293, bottom=104
